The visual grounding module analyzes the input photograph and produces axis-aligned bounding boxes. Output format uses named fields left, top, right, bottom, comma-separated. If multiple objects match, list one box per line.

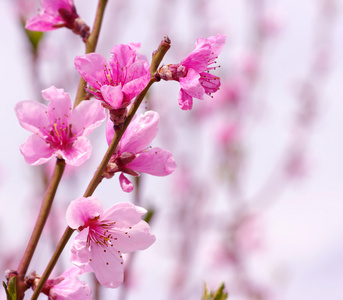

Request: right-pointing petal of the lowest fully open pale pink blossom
left=112, top=220, right=156, bottom=253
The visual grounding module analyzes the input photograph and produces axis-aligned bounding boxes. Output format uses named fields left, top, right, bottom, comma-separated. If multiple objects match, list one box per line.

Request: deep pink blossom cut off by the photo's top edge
left=25, top=0, right=89, bottom=39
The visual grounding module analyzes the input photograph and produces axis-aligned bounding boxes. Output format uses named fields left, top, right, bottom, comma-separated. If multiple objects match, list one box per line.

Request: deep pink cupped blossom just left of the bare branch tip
left=74, top=44, right=150, bottom=109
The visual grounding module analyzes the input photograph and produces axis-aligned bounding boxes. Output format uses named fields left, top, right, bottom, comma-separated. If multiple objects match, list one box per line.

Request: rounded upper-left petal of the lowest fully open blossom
left=66, top=197, right=103, bottom=229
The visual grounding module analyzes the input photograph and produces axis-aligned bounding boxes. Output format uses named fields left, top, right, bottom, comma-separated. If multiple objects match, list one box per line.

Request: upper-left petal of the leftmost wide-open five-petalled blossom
left=15, top=101, right=51, bottom=135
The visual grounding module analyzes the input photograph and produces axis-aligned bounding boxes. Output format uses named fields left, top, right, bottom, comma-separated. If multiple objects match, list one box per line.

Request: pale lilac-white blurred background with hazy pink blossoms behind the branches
left=0, top=0, right=343, bottom=300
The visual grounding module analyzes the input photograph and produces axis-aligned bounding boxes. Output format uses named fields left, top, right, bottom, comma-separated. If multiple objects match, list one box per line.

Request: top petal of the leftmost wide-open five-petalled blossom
left=42, top=86, right=73, bottom=128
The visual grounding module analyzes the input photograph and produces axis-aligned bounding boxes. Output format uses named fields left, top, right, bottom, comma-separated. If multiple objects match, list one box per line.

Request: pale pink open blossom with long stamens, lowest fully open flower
left=66, top=197, right=155, bottom=288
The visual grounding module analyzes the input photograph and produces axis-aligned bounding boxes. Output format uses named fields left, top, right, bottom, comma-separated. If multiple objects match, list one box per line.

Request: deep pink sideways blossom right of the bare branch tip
left=158, top=34, right=225, bottom=110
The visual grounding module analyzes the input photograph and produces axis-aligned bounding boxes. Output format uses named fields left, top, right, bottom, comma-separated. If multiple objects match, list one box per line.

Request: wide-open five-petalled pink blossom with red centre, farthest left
left=15, top=86, right=106, bottom=166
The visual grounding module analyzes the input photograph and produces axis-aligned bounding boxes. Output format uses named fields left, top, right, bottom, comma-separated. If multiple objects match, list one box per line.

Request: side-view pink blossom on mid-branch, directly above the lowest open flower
left=105, top=111, right=176, bottom=192
